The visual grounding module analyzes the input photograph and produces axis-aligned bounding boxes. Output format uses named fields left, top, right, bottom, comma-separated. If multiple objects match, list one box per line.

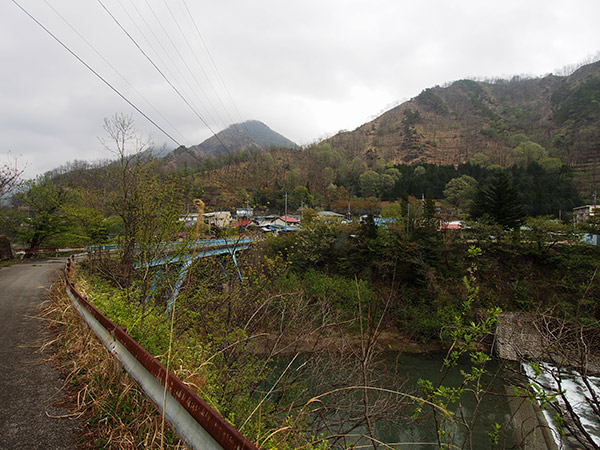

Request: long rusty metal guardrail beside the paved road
left=65, top=257, right=258, bottom=450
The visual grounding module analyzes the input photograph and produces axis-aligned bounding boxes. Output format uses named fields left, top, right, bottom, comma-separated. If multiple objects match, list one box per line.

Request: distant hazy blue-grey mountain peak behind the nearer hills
left=167, top=120, right=298, bottom=165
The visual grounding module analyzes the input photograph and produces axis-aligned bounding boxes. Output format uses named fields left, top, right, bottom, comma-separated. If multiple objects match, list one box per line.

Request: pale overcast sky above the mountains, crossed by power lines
left=0, top=0, right=600, bottom=177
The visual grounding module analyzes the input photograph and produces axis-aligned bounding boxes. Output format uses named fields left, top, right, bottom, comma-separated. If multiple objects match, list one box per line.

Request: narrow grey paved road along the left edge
left=0, top=258, right=78, bottom=450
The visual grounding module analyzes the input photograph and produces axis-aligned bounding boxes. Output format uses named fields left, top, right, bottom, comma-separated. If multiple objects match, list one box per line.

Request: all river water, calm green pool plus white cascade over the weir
left=276, top=352, right=600, bottom=450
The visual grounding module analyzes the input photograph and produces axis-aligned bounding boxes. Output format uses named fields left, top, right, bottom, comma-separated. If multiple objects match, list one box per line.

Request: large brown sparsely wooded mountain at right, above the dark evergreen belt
left=325, top=61, right=600, bottom=193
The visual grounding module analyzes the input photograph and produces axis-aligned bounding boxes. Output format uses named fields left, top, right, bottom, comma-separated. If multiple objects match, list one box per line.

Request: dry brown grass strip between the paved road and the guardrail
left=43, top=274, right=185, bottom=449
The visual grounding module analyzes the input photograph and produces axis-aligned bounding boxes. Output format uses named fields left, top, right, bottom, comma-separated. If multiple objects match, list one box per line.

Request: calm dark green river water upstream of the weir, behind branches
left=276, top=352, right=515, bottom=450
